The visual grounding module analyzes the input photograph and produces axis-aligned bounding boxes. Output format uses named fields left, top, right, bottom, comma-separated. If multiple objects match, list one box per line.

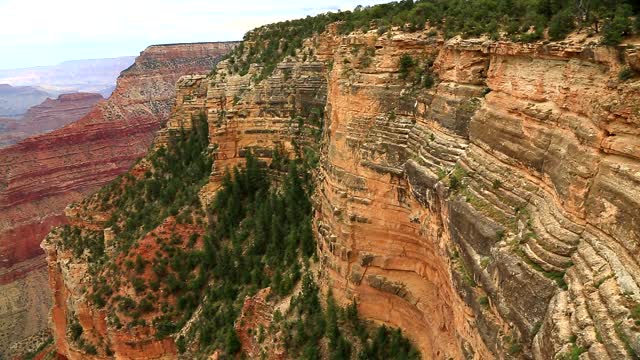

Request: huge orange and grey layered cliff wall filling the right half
left=317, top=29, right=640, bottom=359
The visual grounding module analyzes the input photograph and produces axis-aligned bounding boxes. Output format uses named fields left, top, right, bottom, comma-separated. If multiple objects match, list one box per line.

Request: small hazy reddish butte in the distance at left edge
left=0, top=93, right=104, bottom=147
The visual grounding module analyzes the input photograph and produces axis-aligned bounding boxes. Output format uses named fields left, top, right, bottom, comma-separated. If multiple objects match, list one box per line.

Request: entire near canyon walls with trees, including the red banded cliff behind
left=0, top=1, right=640, bottom=360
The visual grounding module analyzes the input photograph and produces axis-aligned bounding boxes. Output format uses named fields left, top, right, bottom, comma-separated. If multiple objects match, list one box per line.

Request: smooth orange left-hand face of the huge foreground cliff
left=316, top=29, right=491, bottom=359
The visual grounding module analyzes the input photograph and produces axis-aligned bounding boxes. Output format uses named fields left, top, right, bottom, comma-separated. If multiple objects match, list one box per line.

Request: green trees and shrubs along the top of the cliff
left=228, top=0, right=640, bottom=82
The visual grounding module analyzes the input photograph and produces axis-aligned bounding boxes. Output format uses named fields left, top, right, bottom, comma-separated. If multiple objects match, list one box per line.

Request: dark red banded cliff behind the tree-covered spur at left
left=0, top=43, right=235, bottom=358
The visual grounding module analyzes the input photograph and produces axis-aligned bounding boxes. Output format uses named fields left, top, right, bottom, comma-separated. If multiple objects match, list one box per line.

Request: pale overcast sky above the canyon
left=0, top=0, right=387, bottom=69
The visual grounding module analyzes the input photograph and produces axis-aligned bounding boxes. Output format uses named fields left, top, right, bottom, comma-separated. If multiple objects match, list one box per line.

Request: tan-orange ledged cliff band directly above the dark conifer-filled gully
left=156, top=39, right=327, bottom=191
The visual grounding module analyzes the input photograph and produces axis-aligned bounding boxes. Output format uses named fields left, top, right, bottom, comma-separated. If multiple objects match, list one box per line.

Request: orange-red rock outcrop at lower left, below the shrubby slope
left=42, top=212, right=185, bottom=360
